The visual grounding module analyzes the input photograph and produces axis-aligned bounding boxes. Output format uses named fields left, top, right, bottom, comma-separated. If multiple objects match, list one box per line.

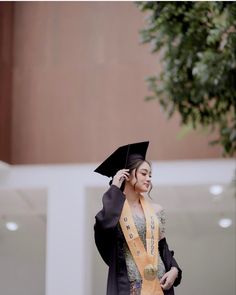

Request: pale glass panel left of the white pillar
left=0, top=189, right=47, bottom=295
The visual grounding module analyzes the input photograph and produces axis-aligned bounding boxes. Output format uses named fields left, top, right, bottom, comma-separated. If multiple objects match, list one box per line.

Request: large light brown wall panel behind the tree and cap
left=7, top=2, right=220, bottom=163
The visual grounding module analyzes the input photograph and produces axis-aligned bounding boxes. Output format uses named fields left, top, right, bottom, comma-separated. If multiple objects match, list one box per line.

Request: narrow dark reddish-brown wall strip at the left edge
left=0, top=2, right=13, bottom=162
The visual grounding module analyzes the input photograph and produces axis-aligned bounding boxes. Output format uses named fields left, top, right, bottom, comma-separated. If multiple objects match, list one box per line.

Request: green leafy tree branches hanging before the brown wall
left=136, top=1, right=236, bottom=156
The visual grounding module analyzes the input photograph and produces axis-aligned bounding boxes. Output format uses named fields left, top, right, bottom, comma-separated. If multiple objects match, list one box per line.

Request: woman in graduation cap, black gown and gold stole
left=94, top=142, right=182, bottom=295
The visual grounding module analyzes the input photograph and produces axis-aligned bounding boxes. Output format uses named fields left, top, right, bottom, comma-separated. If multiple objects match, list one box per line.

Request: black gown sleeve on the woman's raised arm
left=94, top=185, right=125, bottom=266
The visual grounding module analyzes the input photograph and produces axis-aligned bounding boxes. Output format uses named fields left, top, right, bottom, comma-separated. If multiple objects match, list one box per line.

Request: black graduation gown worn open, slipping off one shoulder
left=94, top=185, right=182, bottom=295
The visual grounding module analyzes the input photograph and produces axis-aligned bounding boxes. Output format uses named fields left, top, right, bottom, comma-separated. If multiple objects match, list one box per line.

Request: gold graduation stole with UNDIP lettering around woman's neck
left=120, top=195, right=164, bottom=295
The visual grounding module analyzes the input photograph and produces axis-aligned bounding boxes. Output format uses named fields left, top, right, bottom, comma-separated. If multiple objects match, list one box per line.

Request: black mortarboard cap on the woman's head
left=94, top=141, right=149, bottom=177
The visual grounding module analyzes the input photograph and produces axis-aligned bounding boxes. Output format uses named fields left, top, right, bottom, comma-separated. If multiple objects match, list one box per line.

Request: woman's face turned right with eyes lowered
left=130, top=162, right=152, bottom=193
